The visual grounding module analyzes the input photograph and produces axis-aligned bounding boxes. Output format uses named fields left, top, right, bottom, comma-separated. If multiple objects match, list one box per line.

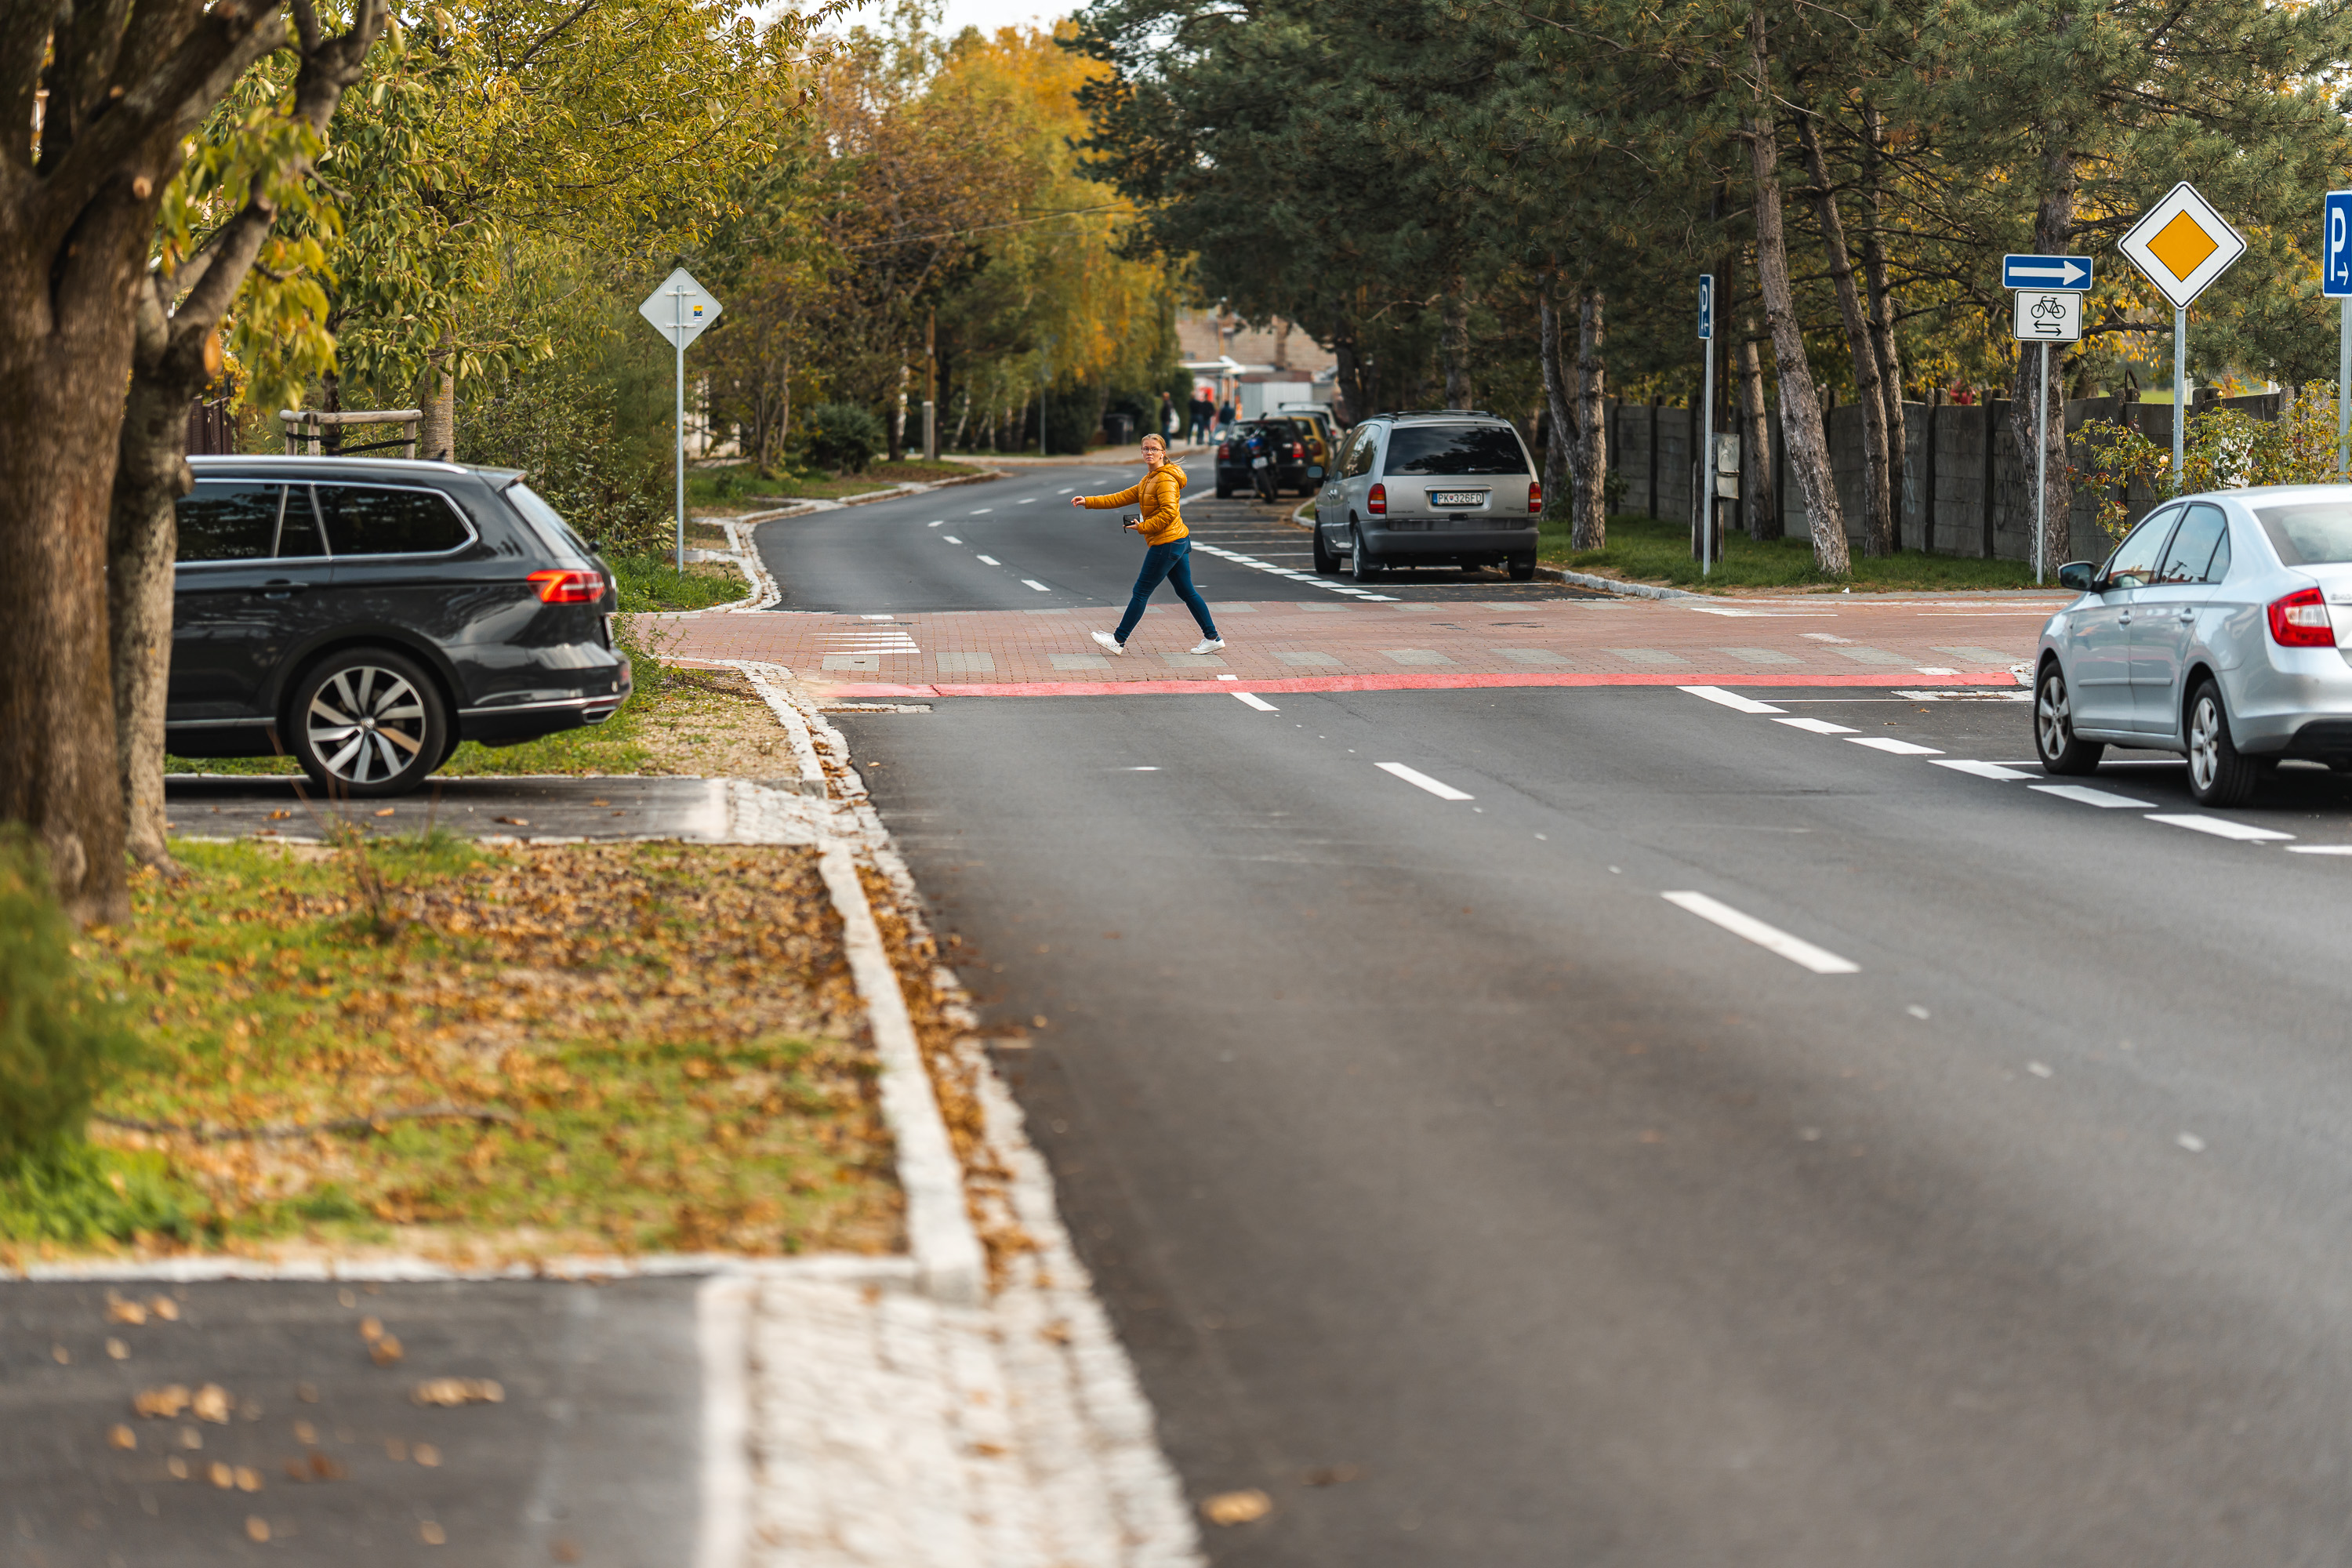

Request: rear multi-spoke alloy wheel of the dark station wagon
left=289, top=649, right=449, bottom=797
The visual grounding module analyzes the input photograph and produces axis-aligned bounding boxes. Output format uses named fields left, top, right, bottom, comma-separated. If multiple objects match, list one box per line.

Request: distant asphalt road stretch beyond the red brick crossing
left=757, top=454, right=1588, bottom=614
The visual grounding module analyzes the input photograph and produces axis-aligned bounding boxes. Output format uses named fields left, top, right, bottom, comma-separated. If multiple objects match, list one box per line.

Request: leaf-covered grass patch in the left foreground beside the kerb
left=0, top=837, right=901, bottom=1260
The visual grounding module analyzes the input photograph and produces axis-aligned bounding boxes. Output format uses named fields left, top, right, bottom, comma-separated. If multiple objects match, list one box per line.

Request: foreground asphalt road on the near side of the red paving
left=847, top=677, right=2352, bottom=1568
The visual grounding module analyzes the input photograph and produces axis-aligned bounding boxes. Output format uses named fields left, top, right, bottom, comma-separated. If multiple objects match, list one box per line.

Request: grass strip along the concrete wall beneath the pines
left=1541, top=513, right=2034, bottom=593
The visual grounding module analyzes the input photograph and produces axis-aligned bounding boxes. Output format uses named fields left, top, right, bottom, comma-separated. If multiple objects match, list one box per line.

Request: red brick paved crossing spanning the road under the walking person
left=668, top=595, right=2067, bottom=699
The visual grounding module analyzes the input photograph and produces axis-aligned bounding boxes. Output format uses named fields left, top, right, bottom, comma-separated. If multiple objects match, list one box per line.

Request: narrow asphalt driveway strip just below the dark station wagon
left=165, top=774, right=727, bottom=841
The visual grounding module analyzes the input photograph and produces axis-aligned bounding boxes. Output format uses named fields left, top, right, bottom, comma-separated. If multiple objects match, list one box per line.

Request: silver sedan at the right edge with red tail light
left=2034, top=485, right=2352, bottom=806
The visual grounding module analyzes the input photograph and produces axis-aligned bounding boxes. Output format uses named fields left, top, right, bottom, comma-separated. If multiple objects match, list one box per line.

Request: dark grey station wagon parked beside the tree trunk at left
left=165, top=456, right=630, bottom=794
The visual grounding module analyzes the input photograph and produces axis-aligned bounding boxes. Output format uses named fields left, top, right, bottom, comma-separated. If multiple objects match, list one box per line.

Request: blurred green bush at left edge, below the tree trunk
left=0, top=837, right=139, bottom=1161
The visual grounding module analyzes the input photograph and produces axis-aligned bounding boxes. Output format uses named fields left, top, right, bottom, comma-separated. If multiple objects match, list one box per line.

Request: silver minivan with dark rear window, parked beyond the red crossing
left=1315, top=409, right=1543, bottom=583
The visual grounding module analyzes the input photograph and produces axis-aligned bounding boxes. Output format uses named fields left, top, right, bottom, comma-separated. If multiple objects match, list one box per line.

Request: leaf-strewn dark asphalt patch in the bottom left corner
left=0, top=1279, right=701, bottom=1568
